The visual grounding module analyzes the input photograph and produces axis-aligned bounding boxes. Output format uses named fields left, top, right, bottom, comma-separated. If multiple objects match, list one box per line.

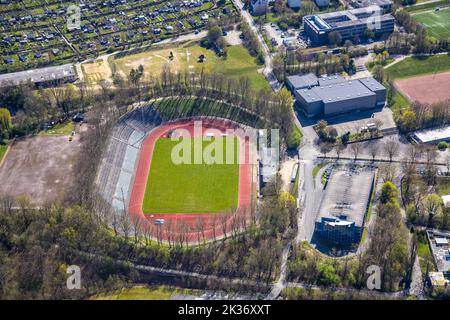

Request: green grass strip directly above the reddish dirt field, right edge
left=386, top=54, right=450, bottom=79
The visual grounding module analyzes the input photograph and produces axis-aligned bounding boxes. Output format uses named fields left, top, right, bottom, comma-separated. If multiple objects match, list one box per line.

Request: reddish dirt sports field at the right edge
left=395, top=72, right=450, bottom=103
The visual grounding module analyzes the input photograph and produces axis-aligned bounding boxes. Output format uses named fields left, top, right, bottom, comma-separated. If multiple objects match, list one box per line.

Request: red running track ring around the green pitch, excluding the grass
left=128, top=119, right=256, bottom=243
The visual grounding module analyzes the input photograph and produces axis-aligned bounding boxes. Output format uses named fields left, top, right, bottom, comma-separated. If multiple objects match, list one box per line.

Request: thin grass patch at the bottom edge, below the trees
left=90, top=286, right=199, bottom=300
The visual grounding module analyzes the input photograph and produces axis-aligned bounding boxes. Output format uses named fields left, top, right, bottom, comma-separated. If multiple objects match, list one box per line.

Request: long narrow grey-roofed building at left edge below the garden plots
left=0, top=64, right=76, bottom=87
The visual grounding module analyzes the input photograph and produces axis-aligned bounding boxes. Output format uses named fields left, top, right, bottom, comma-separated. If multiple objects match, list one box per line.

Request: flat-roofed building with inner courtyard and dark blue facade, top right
left=303, top=5, right=395, bottom=46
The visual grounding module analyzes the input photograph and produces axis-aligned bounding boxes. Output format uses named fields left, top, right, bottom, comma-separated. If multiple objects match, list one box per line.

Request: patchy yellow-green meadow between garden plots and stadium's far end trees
left=112, top=43, right=270, bottom=90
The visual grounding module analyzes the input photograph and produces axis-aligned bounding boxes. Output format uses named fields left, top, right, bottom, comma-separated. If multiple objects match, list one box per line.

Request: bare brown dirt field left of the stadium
left=0, top=125, right=84, bottom=206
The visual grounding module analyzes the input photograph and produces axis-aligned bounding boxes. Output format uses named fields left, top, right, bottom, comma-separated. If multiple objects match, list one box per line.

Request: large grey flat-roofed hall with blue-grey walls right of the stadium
left=287, top=73, right=386, bottom=117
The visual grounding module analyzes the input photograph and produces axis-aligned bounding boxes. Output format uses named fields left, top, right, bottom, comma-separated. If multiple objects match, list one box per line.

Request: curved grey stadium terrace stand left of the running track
left=96, top=106, right=163, bottom=210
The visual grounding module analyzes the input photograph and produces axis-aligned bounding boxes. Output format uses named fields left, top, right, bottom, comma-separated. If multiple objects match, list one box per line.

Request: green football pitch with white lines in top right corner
left=413, top=8, right=450, bottom=39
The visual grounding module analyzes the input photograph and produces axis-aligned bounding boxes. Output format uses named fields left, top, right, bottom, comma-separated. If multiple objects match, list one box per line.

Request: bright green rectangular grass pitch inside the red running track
left=142, top=137, right=243, bottom=214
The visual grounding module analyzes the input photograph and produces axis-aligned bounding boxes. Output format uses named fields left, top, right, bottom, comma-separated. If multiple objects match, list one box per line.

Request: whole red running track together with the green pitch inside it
left=128, top=118, right=256, bottom=244
